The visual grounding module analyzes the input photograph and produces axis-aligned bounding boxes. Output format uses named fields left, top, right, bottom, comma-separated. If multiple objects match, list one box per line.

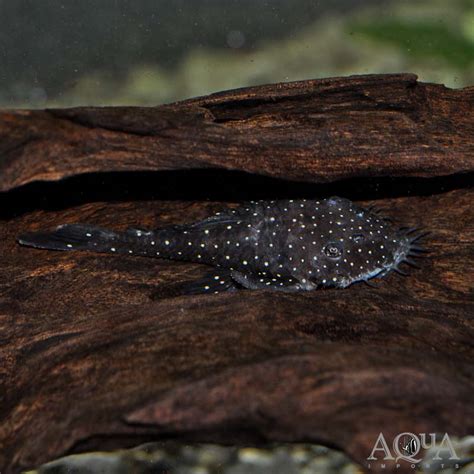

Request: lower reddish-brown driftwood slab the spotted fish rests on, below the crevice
left=0, top=179, right=474, bottom=472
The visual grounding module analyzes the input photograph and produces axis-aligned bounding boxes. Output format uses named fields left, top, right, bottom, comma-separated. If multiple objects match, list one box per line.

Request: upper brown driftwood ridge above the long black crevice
left=0, top=74, right=474, bottom=191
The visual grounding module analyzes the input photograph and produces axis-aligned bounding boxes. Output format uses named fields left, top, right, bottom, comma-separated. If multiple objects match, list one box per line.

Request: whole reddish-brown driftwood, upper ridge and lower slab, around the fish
left=0, top=75, right=474, bottom=473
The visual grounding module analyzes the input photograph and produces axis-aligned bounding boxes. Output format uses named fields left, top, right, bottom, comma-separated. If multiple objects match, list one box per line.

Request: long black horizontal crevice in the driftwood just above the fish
left=0, top=169, right=474, bottom=219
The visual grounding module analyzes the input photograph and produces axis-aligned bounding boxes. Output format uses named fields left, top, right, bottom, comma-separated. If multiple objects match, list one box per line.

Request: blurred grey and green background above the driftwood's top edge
left=0, top=0, right=474, bottom=108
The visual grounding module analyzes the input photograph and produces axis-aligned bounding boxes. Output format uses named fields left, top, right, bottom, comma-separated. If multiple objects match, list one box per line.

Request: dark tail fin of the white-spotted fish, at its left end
left=18, top=224, right=123, bottom=252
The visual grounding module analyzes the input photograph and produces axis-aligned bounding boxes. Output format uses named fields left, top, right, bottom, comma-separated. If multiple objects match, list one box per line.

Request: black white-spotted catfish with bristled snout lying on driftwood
left=18, top=196, right=426, bottom=294
